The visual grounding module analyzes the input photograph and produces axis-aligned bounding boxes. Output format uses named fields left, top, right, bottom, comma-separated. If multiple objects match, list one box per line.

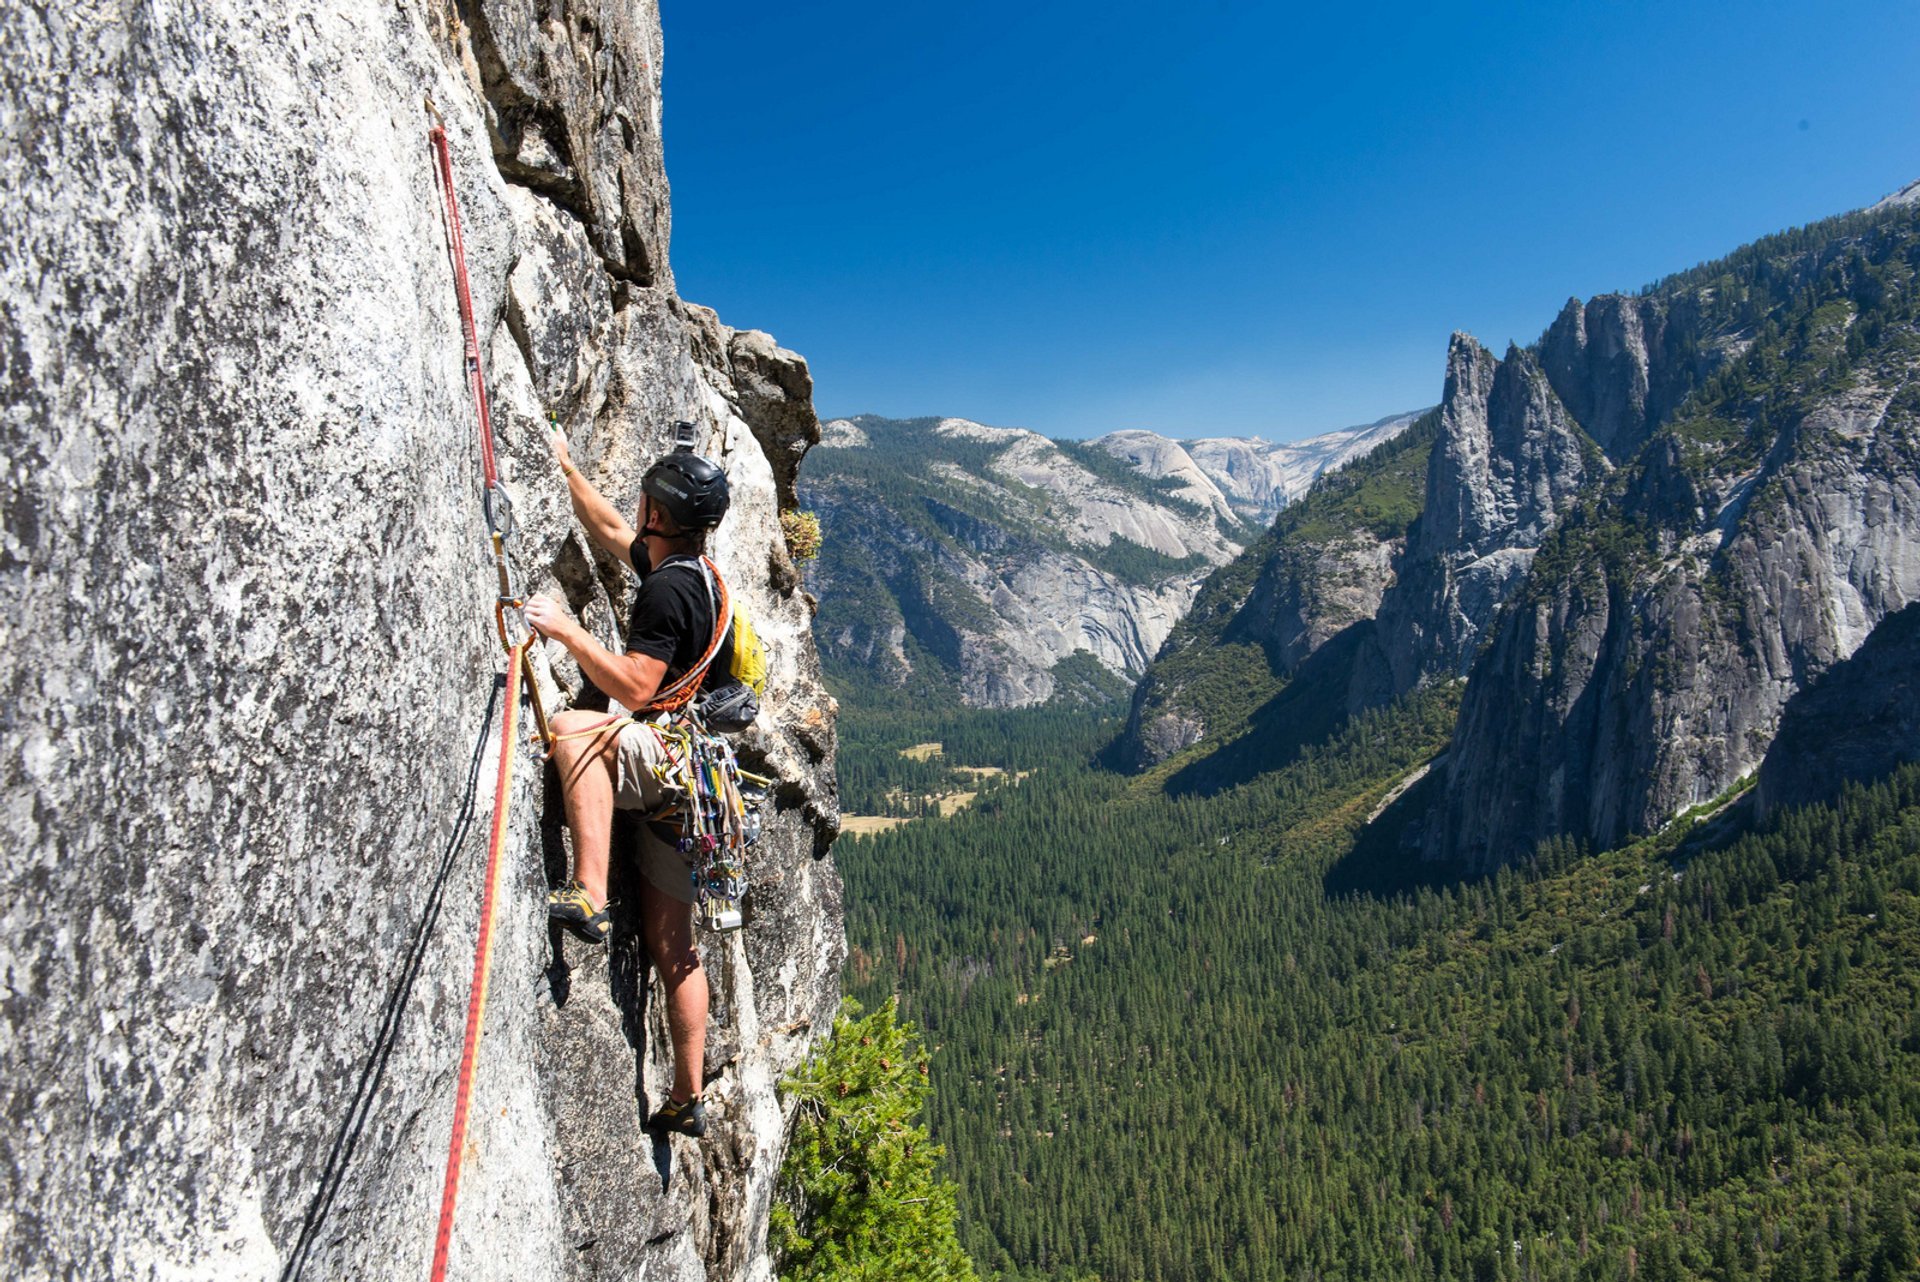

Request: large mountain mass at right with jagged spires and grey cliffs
left=1135, top=202, right=1920, bottom=867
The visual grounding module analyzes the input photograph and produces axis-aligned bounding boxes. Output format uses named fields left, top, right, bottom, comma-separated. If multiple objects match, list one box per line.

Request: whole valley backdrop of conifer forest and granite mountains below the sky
left=803, top=192, right=1920, bottom=1278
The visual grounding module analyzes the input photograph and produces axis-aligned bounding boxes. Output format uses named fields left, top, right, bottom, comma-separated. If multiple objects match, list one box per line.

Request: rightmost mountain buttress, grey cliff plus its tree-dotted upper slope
left=1427, top=211, right=1920, bottom=866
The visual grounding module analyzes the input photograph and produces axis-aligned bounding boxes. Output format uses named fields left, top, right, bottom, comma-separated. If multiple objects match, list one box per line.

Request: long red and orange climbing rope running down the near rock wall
left=426, top=98, right=553, bottom=1282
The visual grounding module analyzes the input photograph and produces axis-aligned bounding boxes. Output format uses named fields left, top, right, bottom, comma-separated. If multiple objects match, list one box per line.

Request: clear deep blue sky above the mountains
left=660, top=0, right=1920, bottom=439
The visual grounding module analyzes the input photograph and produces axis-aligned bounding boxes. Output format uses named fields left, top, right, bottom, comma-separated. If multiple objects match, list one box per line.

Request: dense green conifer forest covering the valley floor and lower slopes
left=835, top=685, right=1920, bottom=1282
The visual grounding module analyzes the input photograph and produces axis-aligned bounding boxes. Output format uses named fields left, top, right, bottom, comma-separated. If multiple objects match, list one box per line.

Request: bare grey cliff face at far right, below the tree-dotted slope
left=1428, top=370, right=1920, bottom=864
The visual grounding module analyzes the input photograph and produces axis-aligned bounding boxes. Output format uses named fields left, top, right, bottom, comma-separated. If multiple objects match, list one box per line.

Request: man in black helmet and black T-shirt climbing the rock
left=526, top=424, right=732, bottom=1136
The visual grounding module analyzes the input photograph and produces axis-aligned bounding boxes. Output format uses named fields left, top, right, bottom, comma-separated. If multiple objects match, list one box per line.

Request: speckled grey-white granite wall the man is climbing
left=0, top=2, right=843, bottom=1278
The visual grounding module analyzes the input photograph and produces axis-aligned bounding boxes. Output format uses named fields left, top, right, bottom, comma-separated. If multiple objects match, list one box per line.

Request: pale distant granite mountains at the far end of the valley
left=803, top=416, right=1411, bottom=706
